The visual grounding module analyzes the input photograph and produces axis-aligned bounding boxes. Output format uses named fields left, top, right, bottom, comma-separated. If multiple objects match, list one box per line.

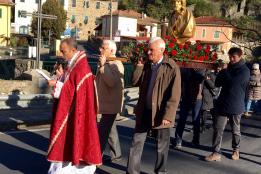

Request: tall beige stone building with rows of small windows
left=67, top=0, right=118, bottom=40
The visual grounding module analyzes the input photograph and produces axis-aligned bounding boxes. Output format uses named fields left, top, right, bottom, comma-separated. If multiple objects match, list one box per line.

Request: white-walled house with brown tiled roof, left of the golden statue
left=97, top=10, right=159, bottom=39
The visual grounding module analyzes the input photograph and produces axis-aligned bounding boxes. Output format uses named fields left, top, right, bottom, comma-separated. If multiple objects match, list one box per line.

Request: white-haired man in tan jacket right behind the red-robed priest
left=96, top=40, right=124, bottom=161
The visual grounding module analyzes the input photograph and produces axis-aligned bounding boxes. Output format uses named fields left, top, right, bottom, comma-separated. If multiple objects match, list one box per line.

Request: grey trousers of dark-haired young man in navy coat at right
left=213, top=115, right=241, bottom=153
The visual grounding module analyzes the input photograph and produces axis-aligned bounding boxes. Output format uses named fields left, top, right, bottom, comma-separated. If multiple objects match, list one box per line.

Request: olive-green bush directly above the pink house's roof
left=193, top=0, right=220, bottom=17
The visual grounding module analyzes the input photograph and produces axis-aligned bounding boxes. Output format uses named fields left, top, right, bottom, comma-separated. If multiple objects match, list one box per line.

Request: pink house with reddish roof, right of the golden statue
left=190, top=16, right=233, bottom=61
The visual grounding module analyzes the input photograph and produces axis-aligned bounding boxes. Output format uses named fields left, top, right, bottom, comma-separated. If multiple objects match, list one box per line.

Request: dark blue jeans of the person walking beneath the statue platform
left=175, top=100, right=202, bottom=144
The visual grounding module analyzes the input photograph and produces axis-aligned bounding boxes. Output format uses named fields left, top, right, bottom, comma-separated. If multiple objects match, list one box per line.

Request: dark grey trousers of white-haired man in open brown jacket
left=126, top=109, right=170, bottom=174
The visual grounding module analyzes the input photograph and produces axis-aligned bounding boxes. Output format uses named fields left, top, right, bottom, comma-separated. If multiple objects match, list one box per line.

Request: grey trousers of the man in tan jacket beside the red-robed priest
left=98, top=114, right=121, bottom=159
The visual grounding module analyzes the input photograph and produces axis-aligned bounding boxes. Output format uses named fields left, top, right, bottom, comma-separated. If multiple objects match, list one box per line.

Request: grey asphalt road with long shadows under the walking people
left=0, top=116, right=261, bottom=174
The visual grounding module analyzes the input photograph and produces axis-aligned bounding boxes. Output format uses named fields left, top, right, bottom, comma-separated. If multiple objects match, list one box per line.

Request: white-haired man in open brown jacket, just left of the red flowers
left=127, top=37, right=181, bottom=174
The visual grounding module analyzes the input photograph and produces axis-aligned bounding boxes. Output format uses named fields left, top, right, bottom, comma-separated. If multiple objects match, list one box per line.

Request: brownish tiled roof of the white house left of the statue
left=103, top=10, right=160, bottom=25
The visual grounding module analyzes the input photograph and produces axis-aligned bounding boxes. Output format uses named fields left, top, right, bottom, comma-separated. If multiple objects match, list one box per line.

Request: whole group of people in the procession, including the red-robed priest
left=47, top=37, right=261, bottom=174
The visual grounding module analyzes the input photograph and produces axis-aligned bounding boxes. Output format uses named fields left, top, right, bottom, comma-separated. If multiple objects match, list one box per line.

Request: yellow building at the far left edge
left=0, top=0, right=14, bottom=46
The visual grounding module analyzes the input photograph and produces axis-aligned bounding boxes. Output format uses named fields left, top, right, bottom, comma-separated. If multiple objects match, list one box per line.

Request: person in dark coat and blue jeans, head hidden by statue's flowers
left=173, top=68, right=205, bottom=149
